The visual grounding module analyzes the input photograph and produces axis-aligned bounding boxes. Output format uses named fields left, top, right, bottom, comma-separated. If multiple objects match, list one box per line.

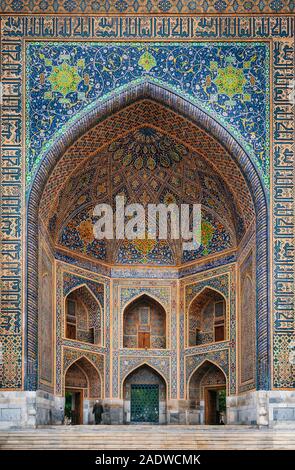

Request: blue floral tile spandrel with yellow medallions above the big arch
left=26, top=42, right=269, bottom=184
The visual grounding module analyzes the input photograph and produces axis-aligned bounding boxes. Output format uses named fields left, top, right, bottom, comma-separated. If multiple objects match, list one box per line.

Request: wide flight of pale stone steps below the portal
left=0, top=425, right=295, bottom=450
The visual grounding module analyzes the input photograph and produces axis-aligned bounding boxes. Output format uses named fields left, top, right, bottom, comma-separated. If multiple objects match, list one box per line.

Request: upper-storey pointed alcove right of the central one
left=188, top=287, right=226, bottom=346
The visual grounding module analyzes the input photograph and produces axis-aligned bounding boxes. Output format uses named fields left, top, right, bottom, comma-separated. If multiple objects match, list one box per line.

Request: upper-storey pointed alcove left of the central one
left=65, top=285, right=101, bottom=345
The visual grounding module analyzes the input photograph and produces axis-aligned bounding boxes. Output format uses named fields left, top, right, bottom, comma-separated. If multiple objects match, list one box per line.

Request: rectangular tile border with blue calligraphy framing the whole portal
left=1, top=13, right=294, bottom=390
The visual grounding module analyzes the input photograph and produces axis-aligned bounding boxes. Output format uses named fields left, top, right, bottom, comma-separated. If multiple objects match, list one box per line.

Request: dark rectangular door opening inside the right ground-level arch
left=204, top=387, right=226, bottom=424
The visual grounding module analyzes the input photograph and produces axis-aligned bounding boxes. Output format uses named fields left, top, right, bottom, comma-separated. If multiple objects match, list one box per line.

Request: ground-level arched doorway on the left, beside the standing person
left=64, top=357, right=101, bottom=425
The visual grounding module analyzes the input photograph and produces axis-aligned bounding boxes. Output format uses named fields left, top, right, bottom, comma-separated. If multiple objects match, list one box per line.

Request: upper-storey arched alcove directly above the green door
left=123, top=294, right=167, bottom=349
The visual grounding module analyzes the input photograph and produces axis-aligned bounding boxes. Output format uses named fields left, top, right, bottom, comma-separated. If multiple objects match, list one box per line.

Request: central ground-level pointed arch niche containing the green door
left=123, top=364, right=167, bottom=424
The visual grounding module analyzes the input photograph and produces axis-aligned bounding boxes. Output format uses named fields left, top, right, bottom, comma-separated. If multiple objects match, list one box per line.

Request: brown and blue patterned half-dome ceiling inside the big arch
left=48, top=124, right=252, bottom=266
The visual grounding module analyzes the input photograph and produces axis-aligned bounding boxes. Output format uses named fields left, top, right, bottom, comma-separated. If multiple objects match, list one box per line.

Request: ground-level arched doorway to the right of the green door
left=189, top=361, right=226, bottom=425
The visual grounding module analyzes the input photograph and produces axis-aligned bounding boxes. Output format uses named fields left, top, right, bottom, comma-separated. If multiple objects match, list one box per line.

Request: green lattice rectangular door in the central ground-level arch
left=131, top=384, right=159, bottom=423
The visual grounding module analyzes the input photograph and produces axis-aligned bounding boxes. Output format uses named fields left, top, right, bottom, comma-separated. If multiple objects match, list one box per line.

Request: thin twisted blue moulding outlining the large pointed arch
left=25, top=82, right=270, bottom=389
